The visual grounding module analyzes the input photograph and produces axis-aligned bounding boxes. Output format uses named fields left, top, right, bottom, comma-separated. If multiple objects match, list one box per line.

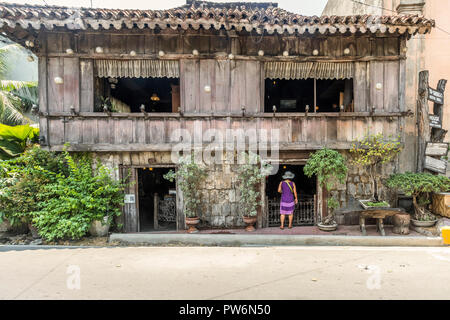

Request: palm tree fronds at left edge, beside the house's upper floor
left=0, top=44, right=38, bottom=125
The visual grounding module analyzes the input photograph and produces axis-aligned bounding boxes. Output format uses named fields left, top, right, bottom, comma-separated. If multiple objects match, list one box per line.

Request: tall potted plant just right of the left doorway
left=163, top=153, right=207, bottom=233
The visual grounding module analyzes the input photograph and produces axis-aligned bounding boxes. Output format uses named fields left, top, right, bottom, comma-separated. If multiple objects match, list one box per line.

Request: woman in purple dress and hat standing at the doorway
left=278, top=171, right=298, bottom=230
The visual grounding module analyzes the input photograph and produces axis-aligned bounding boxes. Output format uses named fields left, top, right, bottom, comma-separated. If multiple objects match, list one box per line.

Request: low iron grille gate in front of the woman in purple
left=266, top=195, right=318, bottom=227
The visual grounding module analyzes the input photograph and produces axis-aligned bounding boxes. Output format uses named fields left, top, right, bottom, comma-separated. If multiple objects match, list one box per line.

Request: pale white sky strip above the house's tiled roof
left=0, top=0, right=327, bottom=16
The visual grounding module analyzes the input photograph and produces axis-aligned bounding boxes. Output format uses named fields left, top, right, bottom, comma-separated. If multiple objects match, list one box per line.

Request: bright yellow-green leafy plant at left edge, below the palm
left=0, top=123, right=39, bottom=160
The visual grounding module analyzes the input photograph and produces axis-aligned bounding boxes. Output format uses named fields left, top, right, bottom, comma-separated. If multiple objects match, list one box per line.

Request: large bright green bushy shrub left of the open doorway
left=32, top=151, right=124, bottom=241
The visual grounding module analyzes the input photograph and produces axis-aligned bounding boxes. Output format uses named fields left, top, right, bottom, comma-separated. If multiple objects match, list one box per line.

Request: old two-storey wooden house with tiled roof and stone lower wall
left=0, top=0, right=434, bottom=232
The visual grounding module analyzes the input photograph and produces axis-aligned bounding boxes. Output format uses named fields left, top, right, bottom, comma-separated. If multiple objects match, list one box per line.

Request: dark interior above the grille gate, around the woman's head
left=266, top=164, right=316, bottom=201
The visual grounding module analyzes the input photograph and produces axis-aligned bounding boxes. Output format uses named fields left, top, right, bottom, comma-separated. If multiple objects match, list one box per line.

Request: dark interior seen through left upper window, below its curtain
left=98, top=78, right=180, bottom=112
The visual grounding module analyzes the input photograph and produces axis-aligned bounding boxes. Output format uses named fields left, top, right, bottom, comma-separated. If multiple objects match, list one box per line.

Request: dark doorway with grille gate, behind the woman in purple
left=266, top=164, right=317, bottom=226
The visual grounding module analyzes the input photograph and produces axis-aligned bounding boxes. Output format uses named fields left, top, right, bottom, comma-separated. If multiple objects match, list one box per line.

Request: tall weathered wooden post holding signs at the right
left=417, top=71, right=431, bottom=172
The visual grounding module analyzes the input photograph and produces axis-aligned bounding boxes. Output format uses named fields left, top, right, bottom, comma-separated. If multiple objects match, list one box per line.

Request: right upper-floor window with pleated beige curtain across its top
left=264, top=62, right=354, bottom=112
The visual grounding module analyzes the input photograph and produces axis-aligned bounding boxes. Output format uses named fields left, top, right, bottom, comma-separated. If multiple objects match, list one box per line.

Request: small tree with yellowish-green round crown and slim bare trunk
left=350, top=133, right=401, bottom=201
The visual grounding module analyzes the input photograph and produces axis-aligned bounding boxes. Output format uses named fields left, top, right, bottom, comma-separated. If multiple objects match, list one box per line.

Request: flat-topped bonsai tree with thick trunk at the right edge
left=386, top=172, right=450, bottom=221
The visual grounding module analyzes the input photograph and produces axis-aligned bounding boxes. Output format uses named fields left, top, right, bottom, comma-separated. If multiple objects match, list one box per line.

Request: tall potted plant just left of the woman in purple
left=238, top=152, right=272, bottom=232
